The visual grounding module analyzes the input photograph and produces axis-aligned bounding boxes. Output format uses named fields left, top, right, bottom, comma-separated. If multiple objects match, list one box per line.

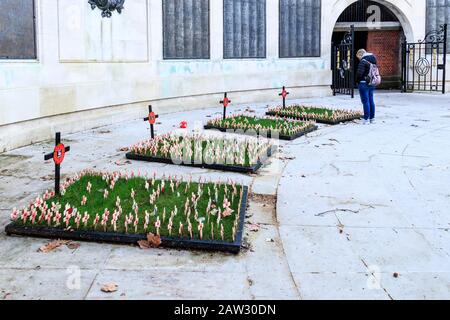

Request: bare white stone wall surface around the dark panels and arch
left=0, top=0, right=440, bottom=152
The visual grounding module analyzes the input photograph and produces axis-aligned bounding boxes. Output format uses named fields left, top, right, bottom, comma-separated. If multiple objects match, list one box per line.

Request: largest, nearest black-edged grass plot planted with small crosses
left=6, top=171, right=248, bottom=252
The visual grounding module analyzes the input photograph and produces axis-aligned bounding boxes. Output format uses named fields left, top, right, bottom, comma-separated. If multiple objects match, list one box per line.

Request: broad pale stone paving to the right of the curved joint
left=277, top=93, right=450, bottom=299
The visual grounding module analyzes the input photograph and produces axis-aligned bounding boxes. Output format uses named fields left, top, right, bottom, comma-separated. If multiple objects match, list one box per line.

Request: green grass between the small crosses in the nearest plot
left=16, top=176, right=242, bottom=242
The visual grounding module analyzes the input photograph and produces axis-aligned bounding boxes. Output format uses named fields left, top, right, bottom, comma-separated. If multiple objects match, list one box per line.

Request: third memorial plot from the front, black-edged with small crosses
left=205, top=115, right=317, bottom=140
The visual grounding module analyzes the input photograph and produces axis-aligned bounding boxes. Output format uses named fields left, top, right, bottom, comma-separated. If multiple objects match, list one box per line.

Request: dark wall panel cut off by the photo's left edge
left=0, top=0, right=36, bottom=59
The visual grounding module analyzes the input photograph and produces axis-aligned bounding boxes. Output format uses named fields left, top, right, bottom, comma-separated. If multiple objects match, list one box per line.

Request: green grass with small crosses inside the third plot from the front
left=210, top=115, right=312, bottom=135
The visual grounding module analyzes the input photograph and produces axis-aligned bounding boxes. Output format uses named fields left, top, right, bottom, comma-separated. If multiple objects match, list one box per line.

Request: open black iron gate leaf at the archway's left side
left=332, top=25, right=355, bottom=98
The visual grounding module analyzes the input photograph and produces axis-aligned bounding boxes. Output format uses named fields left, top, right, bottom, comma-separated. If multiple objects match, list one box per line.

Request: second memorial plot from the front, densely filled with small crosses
left=126, top=133, right=275, bottom=173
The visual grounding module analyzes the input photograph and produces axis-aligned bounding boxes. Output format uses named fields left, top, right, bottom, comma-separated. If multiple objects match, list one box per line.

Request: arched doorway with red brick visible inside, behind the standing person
left=331, top=0, right=405, bottom=90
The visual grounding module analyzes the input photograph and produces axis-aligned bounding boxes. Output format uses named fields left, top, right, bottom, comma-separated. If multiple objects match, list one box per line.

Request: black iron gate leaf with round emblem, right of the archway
left=402, top=24, right=447, bottom=93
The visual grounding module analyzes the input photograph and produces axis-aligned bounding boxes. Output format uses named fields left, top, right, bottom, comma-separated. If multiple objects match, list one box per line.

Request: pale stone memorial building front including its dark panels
left=0, top=0, right=450, bottom=152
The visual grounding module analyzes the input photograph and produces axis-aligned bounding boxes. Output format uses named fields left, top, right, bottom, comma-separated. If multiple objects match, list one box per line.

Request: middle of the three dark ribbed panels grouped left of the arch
left=223, top=0, right=266, bottom=59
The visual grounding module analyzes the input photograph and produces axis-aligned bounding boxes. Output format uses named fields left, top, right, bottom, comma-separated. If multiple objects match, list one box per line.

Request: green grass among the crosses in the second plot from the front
left=131, top=137, right=269, bottom=167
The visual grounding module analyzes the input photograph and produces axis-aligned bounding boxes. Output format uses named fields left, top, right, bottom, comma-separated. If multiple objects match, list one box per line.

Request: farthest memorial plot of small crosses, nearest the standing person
left=267, top=105, right=363, bottom=125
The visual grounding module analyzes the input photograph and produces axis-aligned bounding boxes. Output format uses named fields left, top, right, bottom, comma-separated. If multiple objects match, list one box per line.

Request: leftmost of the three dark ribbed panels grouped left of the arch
left=163, top=0, right=210, bottom=59
